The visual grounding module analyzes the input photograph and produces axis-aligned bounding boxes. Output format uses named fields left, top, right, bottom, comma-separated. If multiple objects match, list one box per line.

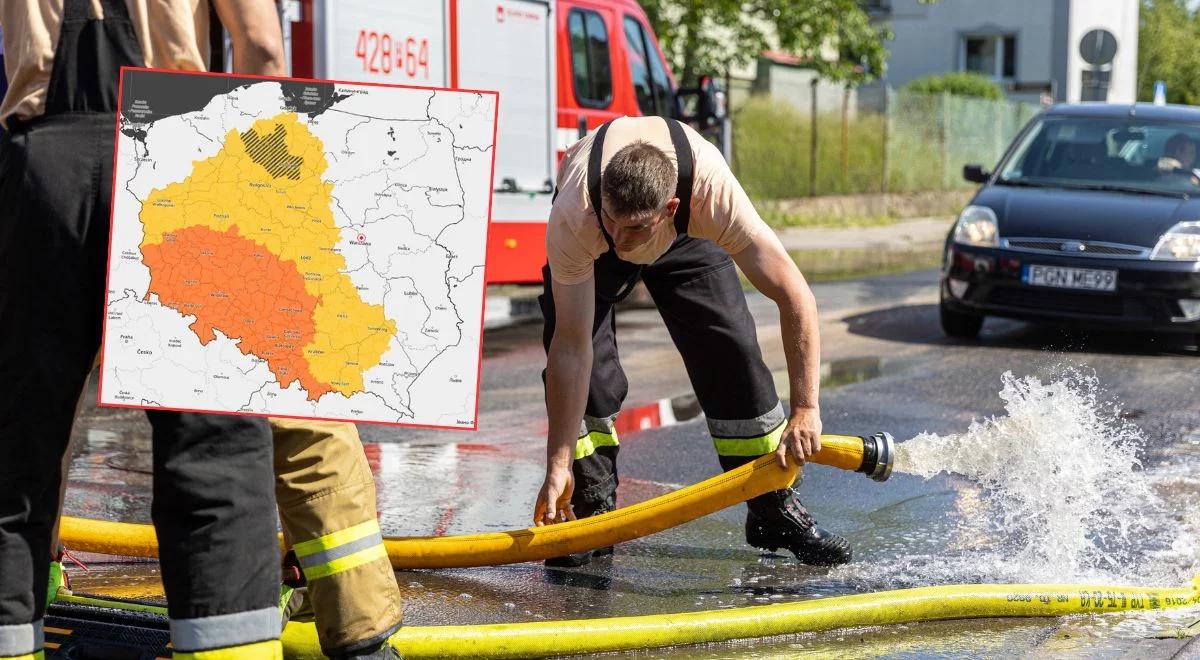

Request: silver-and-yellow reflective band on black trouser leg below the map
left=170, top=607, right=281, bottom=659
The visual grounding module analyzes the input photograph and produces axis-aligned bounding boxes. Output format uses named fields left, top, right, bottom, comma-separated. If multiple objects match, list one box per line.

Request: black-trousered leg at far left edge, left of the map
left=0, top=120, right=112, bottom=659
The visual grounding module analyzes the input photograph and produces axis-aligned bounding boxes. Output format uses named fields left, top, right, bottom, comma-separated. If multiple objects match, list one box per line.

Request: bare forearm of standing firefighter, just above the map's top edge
left=212, top=0, right=288, bottom=76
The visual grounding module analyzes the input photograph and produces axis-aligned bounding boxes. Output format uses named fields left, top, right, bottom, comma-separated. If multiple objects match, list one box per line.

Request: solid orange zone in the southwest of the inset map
left=142, top=226, right=332, bottom=401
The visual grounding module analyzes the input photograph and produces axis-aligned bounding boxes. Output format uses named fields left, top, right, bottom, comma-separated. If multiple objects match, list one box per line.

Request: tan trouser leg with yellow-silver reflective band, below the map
left=270, top=418, right=402, bottom=658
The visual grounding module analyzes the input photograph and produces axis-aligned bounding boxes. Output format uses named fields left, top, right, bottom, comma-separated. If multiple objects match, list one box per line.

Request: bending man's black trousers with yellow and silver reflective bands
left=539, top=235, right=787, bottom=516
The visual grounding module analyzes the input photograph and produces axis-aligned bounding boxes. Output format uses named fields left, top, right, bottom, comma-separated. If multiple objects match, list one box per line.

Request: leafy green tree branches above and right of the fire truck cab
left=642, top=0, right=890, bottom=85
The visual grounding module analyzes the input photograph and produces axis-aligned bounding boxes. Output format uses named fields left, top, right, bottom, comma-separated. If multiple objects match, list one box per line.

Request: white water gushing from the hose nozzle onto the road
left=895, top=371, right=1169, bottom=582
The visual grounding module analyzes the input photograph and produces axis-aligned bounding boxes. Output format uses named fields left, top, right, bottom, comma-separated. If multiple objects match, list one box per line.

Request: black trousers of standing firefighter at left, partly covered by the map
left=0, top=112, right=280, bottom=659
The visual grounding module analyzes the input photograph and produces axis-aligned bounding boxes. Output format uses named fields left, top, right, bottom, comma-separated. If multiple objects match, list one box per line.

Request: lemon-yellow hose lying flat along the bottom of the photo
left=274, top=576, right=1200, bottom=659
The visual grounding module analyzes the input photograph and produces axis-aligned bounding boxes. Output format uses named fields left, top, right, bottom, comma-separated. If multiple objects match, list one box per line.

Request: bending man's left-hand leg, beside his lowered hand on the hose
left=538, top=260, right=629, bottom=565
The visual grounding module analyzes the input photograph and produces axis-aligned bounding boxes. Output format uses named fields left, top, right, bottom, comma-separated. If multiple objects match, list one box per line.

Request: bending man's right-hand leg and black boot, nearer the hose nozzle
left=643, top=239, right=851, bottom=564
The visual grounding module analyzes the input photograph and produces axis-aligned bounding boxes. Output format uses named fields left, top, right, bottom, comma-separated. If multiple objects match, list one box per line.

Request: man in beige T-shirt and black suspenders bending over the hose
left=534, top=116, right=851, bottom=565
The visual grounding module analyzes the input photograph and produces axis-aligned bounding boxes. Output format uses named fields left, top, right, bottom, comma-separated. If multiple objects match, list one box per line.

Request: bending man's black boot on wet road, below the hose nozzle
left=746, top=488, right=852, bottom=566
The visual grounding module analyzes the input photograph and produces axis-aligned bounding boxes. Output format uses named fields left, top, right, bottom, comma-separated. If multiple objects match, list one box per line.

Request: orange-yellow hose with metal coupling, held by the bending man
left=60, top=433, right=895, bottom=569
